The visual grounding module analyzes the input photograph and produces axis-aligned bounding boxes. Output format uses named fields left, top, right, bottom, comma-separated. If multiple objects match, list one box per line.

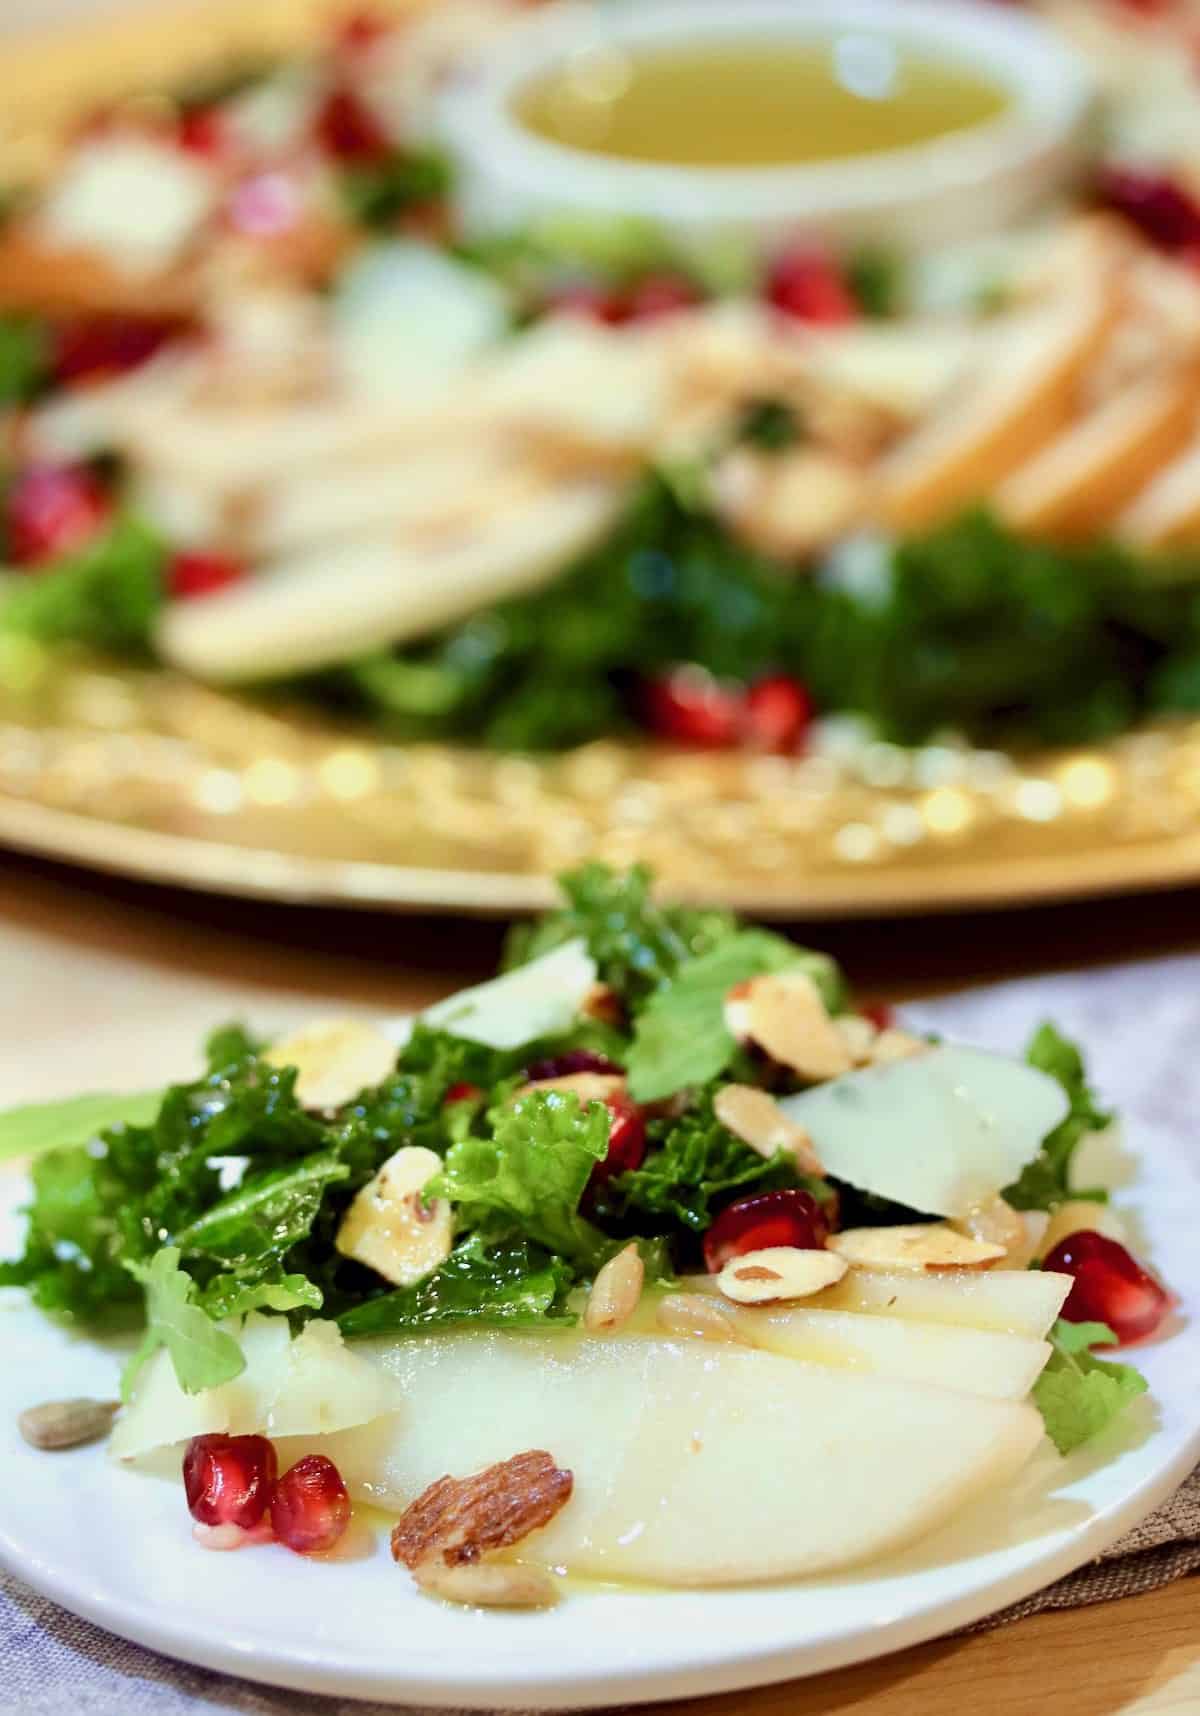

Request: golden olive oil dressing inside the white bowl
left=512, top=33, right=1013, bottom=168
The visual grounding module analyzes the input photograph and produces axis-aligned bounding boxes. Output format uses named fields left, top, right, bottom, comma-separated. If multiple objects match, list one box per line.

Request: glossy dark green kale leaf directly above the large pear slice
left=338, top=1237, right=575, bottom=1337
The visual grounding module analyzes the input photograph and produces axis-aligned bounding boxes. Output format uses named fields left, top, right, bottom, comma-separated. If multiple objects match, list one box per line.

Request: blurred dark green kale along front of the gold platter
left=9, top=477, right=1200, bottom=752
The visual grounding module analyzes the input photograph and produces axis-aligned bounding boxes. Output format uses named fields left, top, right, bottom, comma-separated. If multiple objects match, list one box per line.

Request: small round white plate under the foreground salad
left=0, top=1134, right=1200, bottom=1707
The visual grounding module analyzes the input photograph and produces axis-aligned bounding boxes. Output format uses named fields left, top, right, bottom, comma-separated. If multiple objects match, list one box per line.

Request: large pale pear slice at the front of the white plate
left=314, top=1333, right=1042, bottom=1586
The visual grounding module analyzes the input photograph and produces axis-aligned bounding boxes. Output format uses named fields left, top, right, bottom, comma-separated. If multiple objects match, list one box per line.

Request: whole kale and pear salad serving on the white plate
left=0, top=865, right=1171, bottom=1608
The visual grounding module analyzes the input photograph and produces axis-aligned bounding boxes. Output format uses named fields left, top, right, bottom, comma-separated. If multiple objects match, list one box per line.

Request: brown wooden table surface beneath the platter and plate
left=0, top=858, right=1200, bottom=1716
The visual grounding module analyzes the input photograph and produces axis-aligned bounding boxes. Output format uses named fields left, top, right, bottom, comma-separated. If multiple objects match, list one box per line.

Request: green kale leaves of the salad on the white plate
left=0, top=865, right=1142, bottom=1448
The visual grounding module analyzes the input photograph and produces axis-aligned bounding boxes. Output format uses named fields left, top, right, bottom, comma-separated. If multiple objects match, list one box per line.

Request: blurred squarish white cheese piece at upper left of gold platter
left=36, top=136, right=218, bottom=275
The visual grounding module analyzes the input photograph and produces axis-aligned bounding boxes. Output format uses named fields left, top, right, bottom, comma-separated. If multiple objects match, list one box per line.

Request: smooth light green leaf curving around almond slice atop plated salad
left=625, top=930, right=841, bottom=1102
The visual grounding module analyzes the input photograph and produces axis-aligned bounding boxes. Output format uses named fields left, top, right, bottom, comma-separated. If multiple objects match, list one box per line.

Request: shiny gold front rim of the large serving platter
left=0, top=638, right=1200, bottom=918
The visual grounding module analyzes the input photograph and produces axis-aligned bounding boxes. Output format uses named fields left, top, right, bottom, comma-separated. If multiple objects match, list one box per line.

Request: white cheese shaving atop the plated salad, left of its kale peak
left=421, top=939, right=596, bottom=1048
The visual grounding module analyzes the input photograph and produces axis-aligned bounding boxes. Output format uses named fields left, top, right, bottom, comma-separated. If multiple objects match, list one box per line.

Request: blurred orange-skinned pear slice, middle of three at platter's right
left=994, top=364, right=1200, bottom=537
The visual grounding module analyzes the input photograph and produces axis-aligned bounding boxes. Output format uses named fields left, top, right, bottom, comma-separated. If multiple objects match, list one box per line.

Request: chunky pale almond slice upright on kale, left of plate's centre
left=335, top=1145, right=453, bottom=1287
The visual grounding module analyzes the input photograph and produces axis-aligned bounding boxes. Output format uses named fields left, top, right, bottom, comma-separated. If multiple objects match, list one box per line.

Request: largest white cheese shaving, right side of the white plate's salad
left=779, top=1047, right=1068, bottom=1218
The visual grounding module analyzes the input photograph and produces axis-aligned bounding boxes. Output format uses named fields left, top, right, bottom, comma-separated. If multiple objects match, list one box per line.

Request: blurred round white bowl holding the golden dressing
left=438, top=0, right=1092, bottom=247
